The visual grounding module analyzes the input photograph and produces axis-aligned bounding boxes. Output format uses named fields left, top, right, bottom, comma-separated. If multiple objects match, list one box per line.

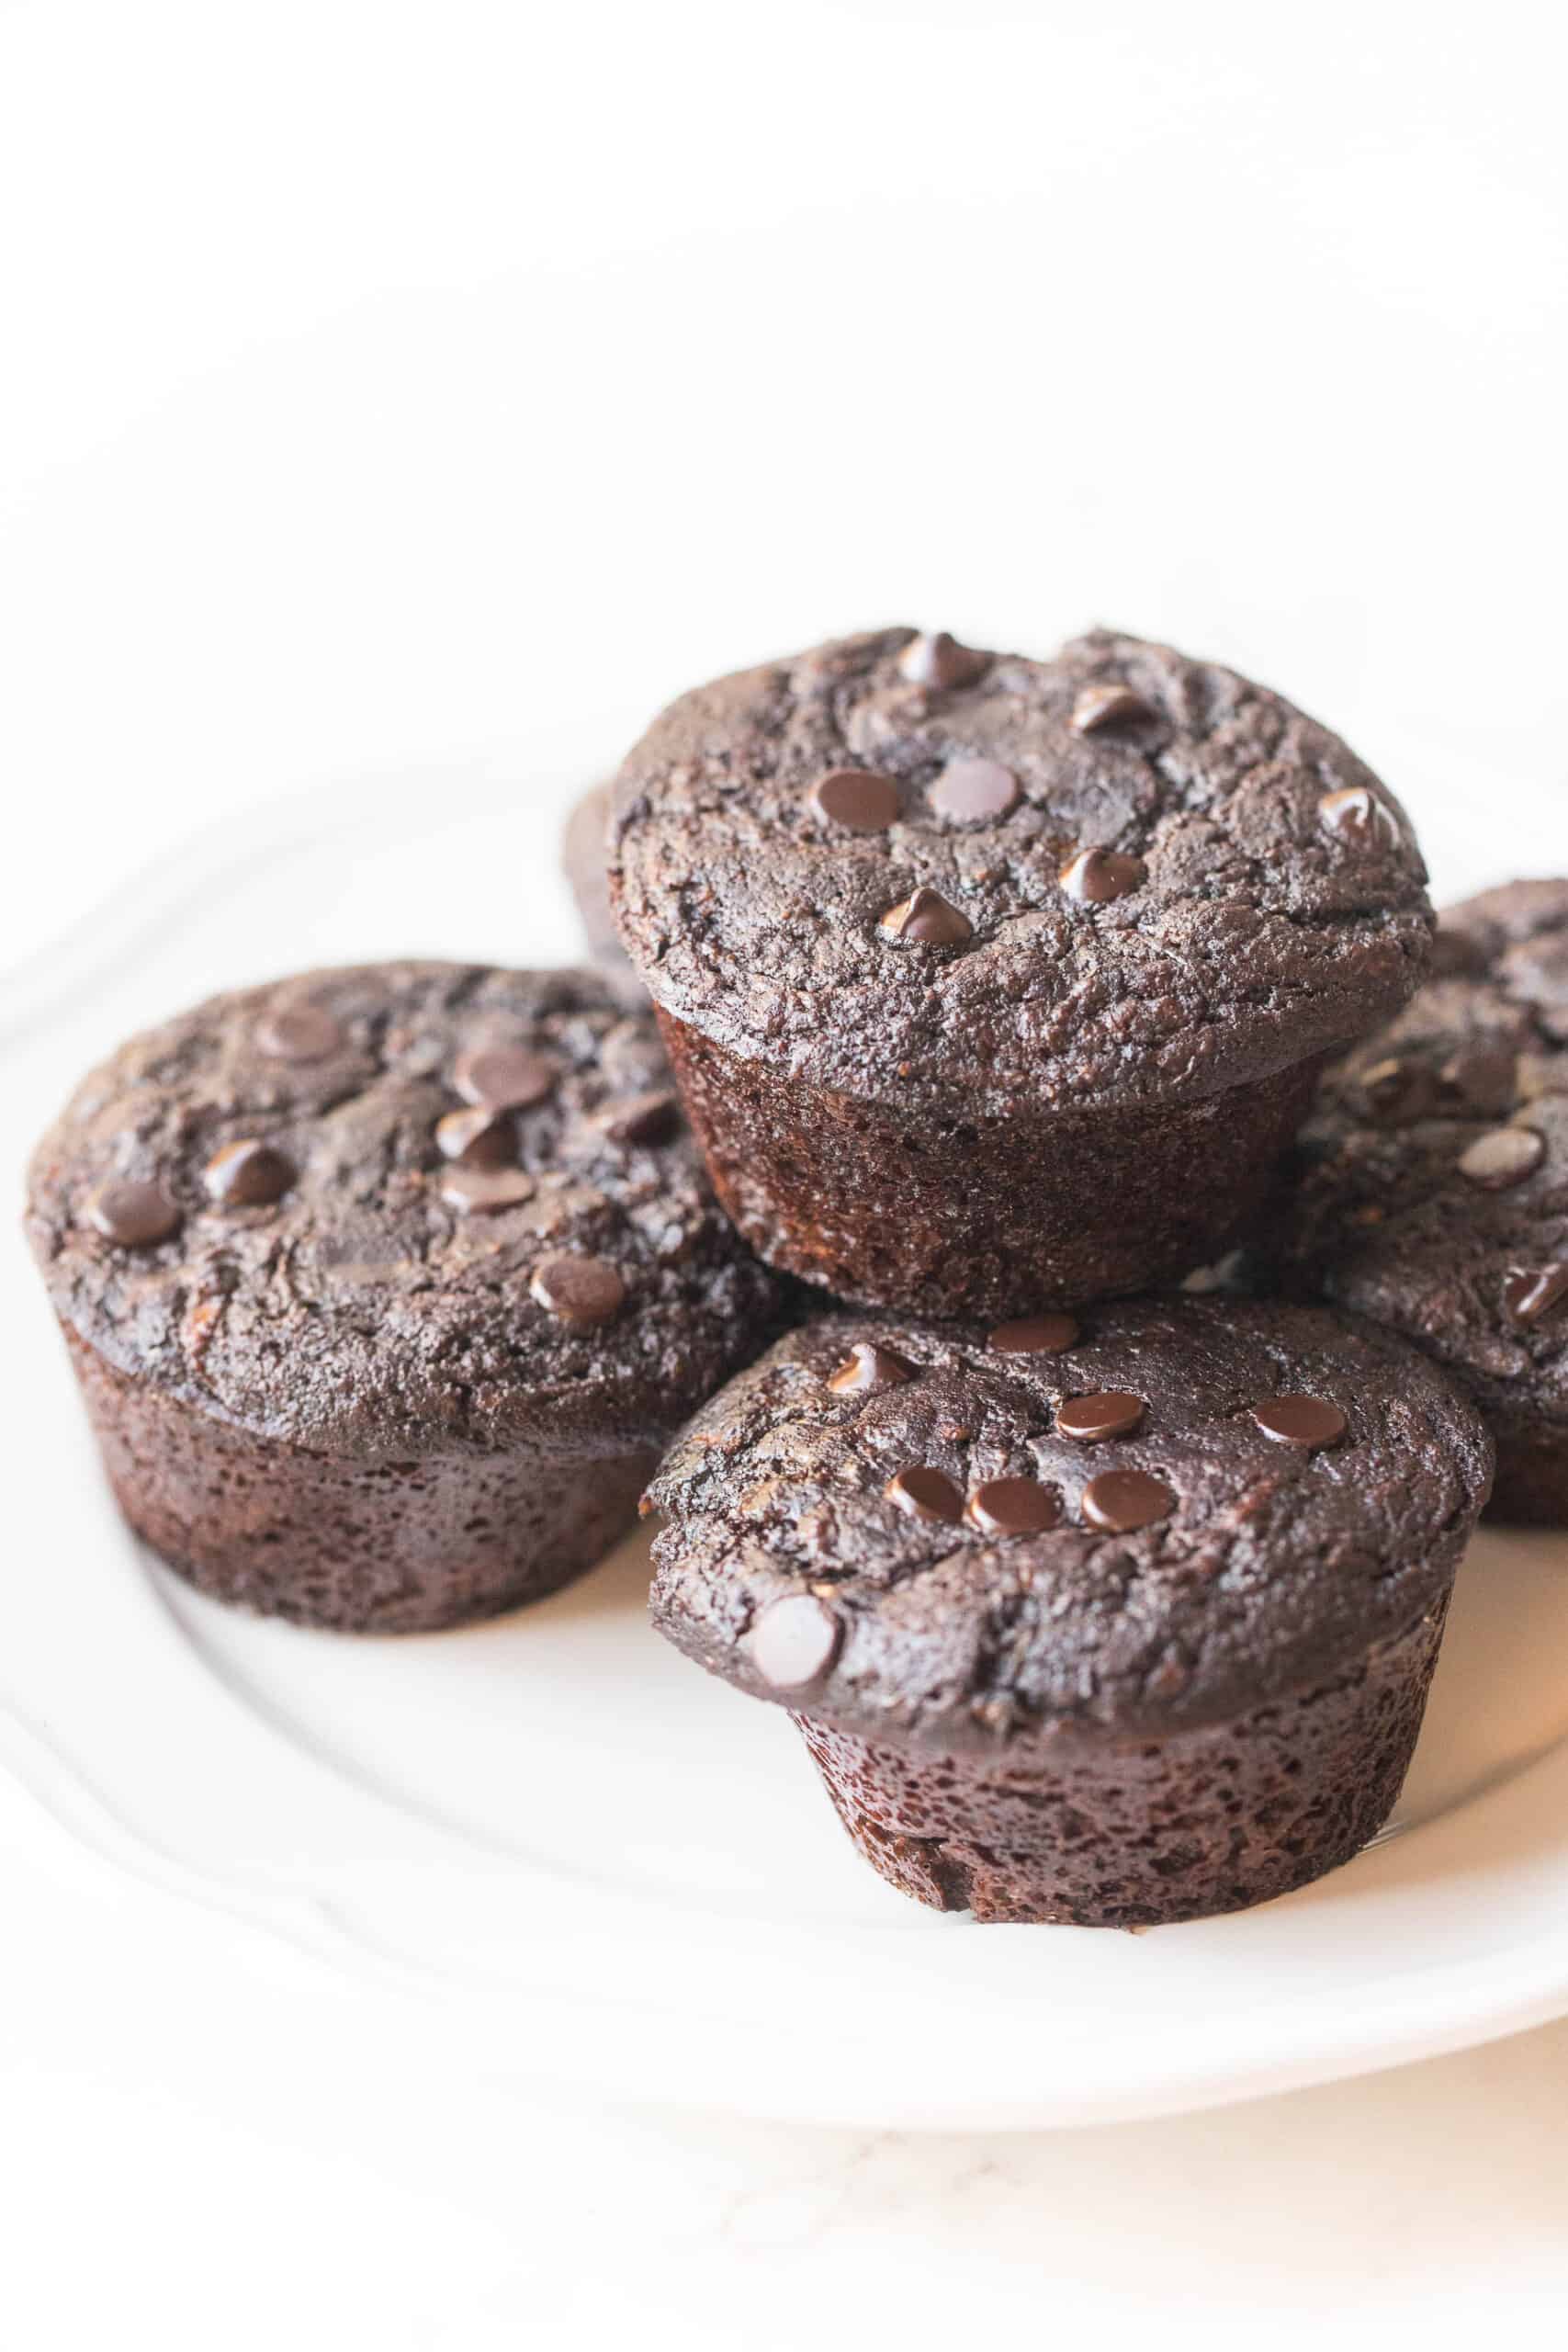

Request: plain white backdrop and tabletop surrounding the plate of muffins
left=0, top=0, right=1568, bottom=2352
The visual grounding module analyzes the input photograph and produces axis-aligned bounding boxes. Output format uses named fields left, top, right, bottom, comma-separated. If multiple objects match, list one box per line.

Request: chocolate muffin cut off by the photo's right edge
left=1265, top=882, right=1568, bottom=1524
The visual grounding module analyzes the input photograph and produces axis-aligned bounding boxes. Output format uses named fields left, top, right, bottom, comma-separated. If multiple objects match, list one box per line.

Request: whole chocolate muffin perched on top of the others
left=611, top=628, right=1429, bottom=1315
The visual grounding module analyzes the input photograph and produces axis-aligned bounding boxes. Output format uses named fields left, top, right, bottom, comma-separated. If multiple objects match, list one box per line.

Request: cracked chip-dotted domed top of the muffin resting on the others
left=611, top=628, right=1432, bottom=1113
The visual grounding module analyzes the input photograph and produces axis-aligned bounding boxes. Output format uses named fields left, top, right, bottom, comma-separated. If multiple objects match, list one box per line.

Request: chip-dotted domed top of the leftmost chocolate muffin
left=28, top=962, right=776, bottom=1456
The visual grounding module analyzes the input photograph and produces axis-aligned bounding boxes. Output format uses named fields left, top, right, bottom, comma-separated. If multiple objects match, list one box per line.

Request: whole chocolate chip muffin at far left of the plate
left=28, top=962, right=773, bottom=1633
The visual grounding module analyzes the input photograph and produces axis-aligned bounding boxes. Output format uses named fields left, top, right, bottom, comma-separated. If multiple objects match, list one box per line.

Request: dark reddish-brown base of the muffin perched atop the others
left=659, top=1009, right=1321, bottom=1317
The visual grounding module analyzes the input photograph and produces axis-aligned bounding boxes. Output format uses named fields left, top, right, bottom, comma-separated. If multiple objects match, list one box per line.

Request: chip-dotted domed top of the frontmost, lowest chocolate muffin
left=651, top=1298, right=1491, bottom=1747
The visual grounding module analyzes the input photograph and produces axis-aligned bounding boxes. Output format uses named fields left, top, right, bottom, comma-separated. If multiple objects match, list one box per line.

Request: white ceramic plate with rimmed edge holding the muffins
left=0, top=748, right=1568, bottom=2126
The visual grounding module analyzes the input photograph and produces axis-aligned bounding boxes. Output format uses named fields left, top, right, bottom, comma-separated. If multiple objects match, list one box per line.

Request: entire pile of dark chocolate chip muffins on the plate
left=30, top=628, right=1568, bottom=1927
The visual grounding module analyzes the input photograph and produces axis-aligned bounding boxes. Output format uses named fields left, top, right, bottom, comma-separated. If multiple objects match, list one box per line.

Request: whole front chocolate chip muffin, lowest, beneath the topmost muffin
left=651, top=1298, right=1491, bottom=1927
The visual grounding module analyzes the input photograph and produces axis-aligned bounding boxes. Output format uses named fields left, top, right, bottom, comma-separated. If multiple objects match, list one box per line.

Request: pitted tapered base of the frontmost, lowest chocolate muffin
left=795, top=1595, right=1448, bottom=1927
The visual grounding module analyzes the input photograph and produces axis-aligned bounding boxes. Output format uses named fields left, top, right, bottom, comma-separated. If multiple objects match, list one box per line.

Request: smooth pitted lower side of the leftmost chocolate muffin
left=66, top=1331, right=656, bottom=1633
